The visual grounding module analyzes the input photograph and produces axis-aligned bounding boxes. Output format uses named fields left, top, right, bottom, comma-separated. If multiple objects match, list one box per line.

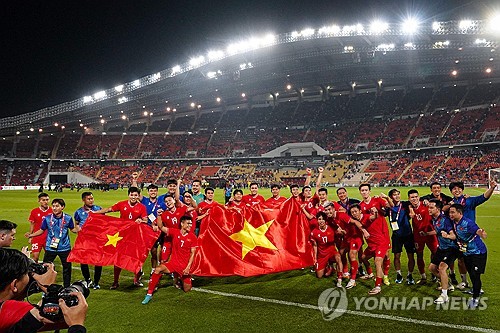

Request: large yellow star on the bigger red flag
left=229, top=220, right=277, bottom=259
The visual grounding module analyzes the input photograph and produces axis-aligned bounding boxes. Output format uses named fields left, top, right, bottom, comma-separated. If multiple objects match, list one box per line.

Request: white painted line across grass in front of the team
left=193, top=287, right=500, bottom=333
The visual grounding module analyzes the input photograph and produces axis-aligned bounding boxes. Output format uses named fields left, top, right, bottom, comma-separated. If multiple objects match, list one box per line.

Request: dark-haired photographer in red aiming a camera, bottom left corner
left=0, top=248, right=88, bottom=333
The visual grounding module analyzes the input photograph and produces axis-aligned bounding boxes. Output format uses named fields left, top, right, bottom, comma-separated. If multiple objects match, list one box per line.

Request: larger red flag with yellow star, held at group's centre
left=191, top=199, right=314, bottom=276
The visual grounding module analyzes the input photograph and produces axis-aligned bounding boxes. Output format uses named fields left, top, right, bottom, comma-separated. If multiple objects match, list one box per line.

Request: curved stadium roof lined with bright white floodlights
left=0, top=20, right=500, bottom=135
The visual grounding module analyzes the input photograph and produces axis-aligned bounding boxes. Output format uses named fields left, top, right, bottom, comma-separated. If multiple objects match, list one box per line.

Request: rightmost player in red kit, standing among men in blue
left=408, top=189, right=438, bottom=285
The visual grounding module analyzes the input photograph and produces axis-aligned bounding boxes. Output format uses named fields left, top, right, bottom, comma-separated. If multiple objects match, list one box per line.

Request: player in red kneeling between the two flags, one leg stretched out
left=142, top=215, right=198, bottom=304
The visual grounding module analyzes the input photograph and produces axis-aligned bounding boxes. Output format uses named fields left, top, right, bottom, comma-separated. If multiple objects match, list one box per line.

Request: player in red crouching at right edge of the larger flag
left=310, top=212, right=342, bottom=287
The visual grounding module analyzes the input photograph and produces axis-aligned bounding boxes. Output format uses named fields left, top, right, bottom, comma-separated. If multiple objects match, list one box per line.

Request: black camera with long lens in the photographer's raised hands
left=37, top=273, right=90, bottom=321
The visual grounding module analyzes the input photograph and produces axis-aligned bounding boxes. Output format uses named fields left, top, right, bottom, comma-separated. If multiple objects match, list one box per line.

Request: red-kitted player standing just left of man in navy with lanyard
left=358, top=183, right=391, bottom=295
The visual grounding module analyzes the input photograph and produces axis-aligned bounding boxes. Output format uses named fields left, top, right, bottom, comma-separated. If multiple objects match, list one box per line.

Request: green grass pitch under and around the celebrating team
left=0, top=188, right=500, bottom=333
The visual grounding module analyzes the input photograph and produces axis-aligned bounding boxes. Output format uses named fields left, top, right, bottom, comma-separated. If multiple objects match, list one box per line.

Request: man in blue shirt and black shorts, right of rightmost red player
left=426, top=198, right=458, bottom=304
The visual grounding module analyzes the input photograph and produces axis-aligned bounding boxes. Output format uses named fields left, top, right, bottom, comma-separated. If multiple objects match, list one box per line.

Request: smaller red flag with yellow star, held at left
left=68, top=214, right=159, bottom=273
